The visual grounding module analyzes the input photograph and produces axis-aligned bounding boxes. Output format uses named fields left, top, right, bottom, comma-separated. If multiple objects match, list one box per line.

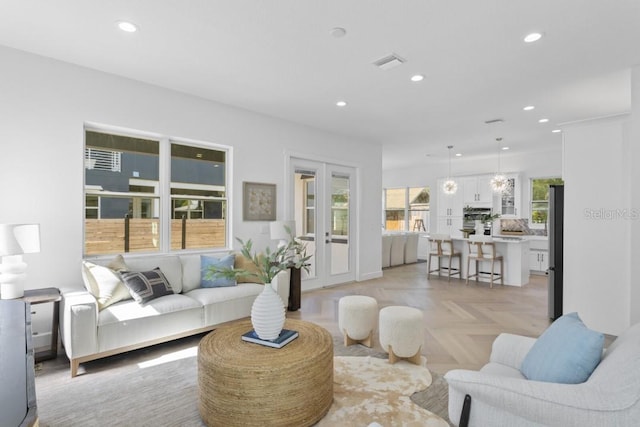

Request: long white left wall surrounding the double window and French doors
left=0, top=47, right=381, bottom=289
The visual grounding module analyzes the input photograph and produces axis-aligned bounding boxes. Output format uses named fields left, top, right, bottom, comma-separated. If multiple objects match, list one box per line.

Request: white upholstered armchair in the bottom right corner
left=445, top=323, right=640, bottom=427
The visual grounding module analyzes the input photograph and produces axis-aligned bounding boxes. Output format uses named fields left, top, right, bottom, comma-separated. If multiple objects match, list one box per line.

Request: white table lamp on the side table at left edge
left=0, top=224, right=40, bottom=299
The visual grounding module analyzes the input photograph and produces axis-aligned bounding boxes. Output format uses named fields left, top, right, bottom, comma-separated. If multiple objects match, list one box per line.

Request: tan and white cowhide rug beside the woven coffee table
left=317, top=356, right=449, bottom=427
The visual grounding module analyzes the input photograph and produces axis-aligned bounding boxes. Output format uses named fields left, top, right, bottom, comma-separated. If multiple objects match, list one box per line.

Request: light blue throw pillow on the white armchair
left=520, top=313, right=604, bottom=384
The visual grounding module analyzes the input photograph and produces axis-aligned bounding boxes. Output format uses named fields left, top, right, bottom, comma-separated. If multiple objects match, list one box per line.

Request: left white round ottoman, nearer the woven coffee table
left=338, top=295, right=378, bottom=347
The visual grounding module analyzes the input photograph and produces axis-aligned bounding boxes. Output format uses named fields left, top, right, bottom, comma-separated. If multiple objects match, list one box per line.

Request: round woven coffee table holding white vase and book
left=198, top=319, right=333, bottom=427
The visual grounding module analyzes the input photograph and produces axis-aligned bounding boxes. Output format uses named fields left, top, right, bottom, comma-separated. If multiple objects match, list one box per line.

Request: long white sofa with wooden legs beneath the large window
left=60, top=253, right=289, bottom=377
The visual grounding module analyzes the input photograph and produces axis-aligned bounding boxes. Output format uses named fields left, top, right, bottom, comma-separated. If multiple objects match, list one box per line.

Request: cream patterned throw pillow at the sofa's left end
left=82, top=261, right=131, bottom=310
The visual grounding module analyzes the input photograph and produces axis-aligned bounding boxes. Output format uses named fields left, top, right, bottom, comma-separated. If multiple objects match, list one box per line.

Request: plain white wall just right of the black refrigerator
left=563, top=116, right=639, bottom=335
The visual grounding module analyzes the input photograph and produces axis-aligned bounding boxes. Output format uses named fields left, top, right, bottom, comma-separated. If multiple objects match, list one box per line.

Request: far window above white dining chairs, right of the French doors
left=384, top=187, right=430, bottom=231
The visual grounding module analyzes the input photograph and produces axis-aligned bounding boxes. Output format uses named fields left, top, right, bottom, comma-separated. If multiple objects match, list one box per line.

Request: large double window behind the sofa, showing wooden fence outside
left=84, top=129, right=227, bottom=255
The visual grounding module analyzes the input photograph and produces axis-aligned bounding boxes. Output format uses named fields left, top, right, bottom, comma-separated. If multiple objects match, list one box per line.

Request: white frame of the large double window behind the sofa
left=82, top=123, right=233, bottom=258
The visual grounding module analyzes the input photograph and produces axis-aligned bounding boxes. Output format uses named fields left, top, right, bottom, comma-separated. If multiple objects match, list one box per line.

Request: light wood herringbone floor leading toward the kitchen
left=287, top=263, right=551, bottom=374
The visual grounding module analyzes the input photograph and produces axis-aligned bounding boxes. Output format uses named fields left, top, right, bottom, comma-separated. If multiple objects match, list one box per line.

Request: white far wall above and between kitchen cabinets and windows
left=382, top=148, right=562, bottom=230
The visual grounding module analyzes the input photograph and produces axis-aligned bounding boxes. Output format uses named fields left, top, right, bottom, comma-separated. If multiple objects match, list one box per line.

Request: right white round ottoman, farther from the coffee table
left=379, top=305, right=424, bottom=365
